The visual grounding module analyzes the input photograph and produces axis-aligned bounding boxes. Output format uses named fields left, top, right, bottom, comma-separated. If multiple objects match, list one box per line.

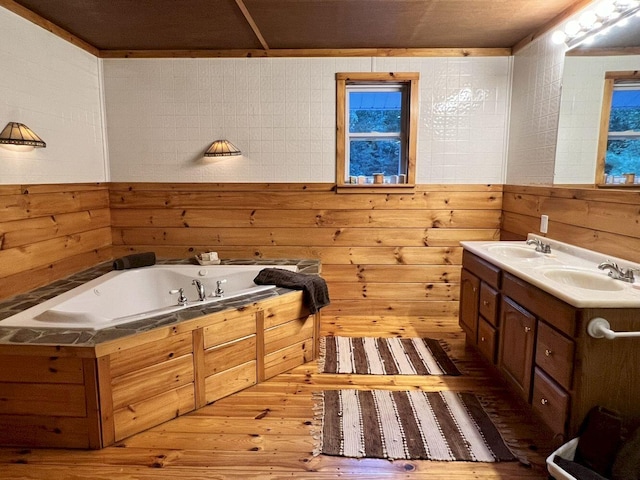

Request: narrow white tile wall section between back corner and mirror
left=506, top=33, right=565, bottom=185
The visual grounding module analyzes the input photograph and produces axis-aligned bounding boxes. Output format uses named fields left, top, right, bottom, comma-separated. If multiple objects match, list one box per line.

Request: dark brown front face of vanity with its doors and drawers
left=459, top=250, right=585, bottom=438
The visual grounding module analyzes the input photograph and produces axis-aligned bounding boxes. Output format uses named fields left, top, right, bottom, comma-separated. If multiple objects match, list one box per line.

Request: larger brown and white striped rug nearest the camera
left=316, top=390, right=516, bottom=462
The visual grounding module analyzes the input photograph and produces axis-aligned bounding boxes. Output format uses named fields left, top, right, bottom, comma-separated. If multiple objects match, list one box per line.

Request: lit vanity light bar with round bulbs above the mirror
left=551, top=0, right=640, bottom=48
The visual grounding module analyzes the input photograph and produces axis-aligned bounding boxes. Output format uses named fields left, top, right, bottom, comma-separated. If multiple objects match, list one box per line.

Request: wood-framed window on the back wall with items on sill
left=336, top=73, right=418, bottom=188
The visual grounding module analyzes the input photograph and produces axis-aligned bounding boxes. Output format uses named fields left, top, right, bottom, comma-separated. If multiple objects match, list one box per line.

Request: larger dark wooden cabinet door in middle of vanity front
left=498, top=298, right=536, bottom=402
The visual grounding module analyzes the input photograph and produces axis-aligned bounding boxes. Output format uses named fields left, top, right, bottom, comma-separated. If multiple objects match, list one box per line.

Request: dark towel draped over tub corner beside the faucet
left=253, top=268, right=330, bottom=313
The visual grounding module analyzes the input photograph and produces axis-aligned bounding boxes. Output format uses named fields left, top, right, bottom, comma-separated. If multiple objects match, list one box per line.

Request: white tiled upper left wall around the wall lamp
left=0, top=8, right=108, bottom=184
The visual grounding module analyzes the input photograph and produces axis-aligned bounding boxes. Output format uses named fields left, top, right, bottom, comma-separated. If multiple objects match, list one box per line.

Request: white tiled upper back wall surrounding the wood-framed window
left=104, top=57, right=511, bottom=183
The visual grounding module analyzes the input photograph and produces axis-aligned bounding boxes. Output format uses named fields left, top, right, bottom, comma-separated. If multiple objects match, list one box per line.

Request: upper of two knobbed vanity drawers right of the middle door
left=536, top=322, right=574, bottom=390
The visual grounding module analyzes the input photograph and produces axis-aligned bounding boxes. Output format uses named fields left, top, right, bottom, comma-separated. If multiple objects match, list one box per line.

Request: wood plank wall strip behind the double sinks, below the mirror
left=502, top=185, right=640, bottom=262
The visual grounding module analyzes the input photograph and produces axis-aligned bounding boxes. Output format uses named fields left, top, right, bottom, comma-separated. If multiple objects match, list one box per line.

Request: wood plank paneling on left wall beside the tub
left=0, top=184, right=111, bottom=298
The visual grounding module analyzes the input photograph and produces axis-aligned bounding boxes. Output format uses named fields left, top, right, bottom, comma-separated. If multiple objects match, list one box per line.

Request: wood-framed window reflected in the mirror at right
left=596, top=72, right=640, bottom=186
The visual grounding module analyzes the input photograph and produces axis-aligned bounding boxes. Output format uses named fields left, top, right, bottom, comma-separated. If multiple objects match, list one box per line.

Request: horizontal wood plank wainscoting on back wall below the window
left=109, top=183, right=502, bottom=318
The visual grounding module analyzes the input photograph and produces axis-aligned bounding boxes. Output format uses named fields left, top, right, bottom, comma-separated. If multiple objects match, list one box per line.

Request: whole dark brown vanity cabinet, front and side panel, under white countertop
left=459, top=248, right=640, bottom=442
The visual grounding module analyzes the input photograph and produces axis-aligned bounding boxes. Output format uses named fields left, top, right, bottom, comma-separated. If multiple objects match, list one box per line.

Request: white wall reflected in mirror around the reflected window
left=555, top=55, right=640, bottom=184
